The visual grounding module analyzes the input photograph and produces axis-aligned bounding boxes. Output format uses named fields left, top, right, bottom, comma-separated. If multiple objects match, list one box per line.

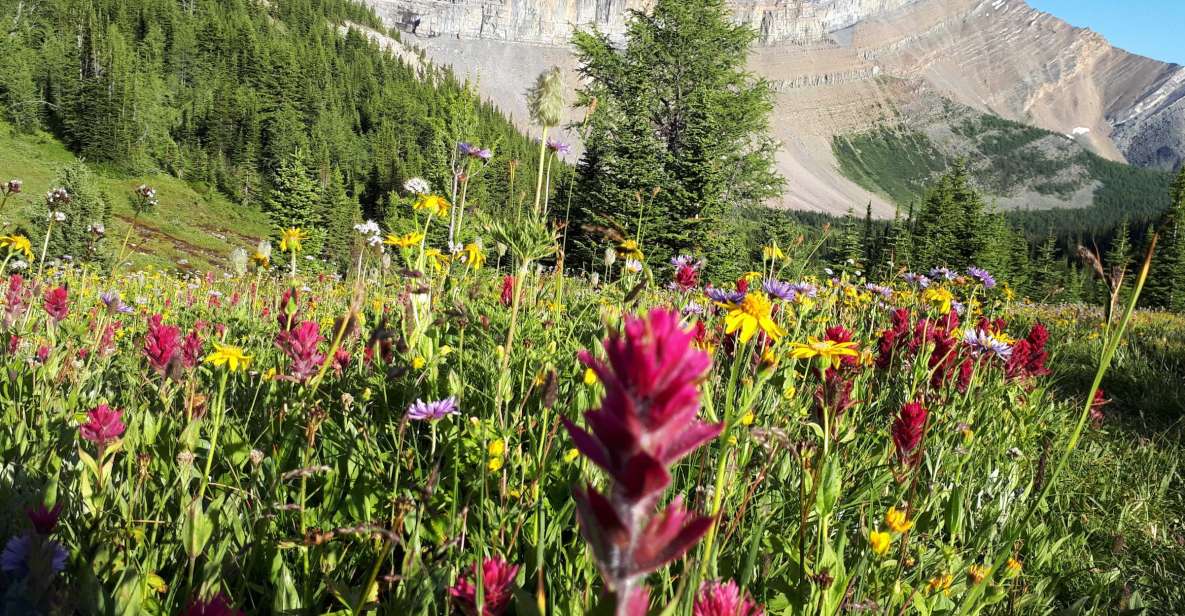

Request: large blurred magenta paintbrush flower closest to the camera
left=564, top=309, right=723, bottom=615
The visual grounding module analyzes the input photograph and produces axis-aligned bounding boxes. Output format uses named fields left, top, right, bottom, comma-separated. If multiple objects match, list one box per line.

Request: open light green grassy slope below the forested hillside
left=0, top=122, right=270, bottom=270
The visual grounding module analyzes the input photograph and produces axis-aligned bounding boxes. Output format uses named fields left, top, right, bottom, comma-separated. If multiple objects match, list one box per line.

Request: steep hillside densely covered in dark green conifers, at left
left=0, top=0, right=552, bottom=254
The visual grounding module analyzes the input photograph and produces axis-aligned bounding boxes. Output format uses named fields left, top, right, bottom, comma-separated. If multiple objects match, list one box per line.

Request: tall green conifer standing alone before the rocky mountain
left=572, top=0, right=781, bottom=269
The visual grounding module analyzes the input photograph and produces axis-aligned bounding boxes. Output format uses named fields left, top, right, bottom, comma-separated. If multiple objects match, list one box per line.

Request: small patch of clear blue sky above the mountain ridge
left=1029, top=0, right=1185, bottom=64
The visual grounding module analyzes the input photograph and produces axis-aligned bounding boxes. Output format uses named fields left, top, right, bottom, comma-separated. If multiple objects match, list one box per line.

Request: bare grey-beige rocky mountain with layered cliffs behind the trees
left=367, top=0, right=1185, bottom=216
